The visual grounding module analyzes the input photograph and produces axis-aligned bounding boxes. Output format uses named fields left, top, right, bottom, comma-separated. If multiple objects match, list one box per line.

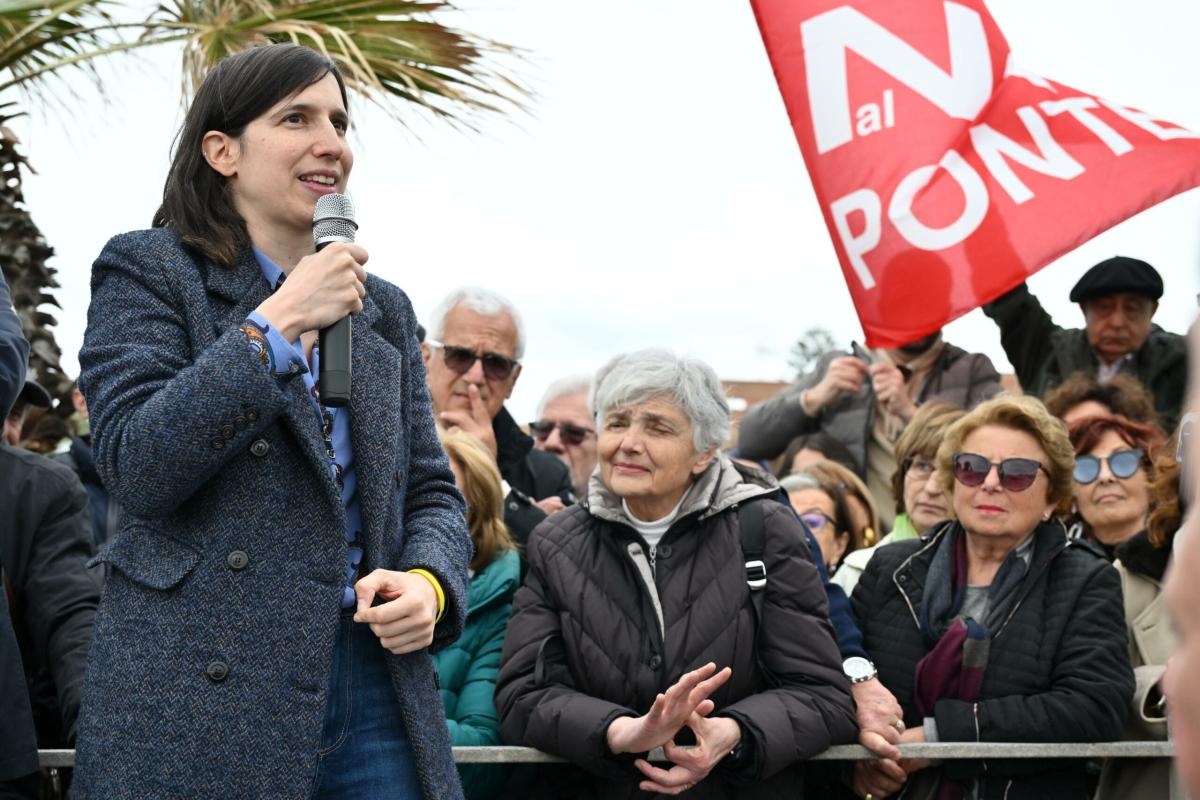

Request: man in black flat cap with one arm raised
left=983, top=255, right=1188, bottom=431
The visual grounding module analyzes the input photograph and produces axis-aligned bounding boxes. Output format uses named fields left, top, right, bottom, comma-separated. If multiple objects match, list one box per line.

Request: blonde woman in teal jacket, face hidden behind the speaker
left=433, top=431, right=521, bottom=798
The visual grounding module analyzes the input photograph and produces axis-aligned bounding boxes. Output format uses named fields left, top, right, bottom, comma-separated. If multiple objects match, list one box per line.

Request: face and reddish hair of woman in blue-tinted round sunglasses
left=1070, top=416, right=1164, bottom=561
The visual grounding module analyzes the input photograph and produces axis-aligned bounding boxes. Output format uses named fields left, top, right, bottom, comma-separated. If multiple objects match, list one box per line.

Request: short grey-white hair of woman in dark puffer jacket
left=589, top=348, right=731, bottom=452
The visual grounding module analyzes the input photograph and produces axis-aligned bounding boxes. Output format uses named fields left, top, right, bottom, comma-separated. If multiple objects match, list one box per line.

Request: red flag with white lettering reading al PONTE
left=750, top=0, right=1200, bottom=347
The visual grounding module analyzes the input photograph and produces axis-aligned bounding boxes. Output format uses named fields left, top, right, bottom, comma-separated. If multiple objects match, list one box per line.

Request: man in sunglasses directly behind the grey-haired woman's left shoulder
left=529, top=375, right=596, bottom=498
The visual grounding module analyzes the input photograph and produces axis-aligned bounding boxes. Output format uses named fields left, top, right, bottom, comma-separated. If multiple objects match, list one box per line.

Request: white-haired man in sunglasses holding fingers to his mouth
left=421, top=287, right=575, bottom=545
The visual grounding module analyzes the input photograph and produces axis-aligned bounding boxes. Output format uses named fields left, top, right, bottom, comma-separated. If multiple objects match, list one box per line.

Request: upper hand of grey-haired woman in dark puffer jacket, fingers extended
left=606, top=662, right=733, bottom=753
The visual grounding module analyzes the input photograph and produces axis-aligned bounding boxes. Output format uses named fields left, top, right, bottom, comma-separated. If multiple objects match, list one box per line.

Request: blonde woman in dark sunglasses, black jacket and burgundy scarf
left=851, top=397, right=1134, bottom=800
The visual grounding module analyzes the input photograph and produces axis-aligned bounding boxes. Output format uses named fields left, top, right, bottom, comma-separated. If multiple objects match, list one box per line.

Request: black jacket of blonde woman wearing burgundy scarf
left=851, top=522, right=1134, bottom=800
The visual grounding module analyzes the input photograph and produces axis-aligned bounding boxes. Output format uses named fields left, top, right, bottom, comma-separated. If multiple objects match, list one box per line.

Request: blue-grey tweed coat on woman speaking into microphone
left=74, top=229, right=472, bottom=799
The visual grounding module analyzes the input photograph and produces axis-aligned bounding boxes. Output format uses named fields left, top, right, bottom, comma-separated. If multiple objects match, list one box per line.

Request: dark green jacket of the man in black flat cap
left=983, top=283, right=1188, bottom=431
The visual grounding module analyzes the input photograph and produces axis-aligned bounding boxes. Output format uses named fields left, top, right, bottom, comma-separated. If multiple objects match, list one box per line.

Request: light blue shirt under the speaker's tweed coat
left=247, top=247, right=362, bottom=608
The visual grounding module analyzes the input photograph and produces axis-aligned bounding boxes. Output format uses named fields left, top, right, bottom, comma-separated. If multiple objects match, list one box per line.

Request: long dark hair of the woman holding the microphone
left=154, top=44, right=349, bottom=266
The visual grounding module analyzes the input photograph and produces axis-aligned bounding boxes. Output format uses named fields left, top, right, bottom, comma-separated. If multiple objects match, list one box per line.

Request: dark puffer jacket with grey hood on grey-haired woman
left=496, top=458, right=856, bottom=800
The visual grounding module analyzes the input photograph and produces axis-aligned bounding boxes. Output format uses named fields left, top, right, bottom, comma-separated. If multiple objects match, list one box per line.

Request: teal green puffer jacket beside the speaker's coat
left=433, top=551, right=521, bottom=798
